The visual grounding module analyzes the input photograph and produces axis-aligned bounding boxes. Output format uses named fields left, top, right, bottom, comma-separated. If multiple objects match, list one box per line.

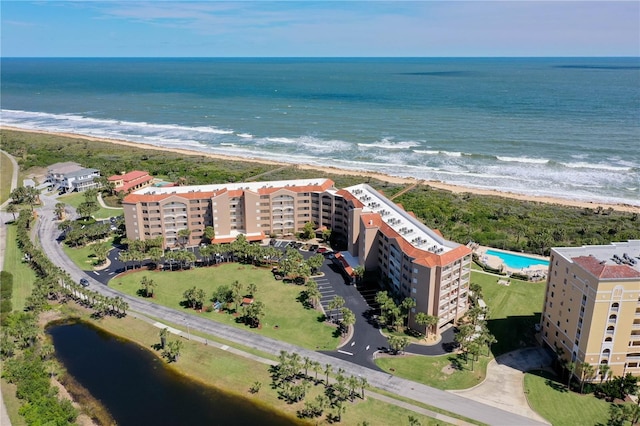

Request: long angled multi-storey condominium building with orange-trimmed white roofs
left=123, top=179, right=471, bottom=329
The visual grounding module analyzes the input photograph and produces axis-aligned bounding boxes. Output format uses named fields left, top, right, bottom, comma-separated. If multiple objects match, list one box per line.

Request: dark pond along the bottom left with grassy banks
left=47, top=322, right=298, bottom=426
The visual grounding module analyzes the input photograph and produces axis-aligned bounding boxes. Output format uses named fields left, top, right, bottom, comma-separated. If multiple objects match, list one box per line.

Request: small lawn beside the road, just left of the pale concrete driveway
left=376, top=354, right=492, bottom=390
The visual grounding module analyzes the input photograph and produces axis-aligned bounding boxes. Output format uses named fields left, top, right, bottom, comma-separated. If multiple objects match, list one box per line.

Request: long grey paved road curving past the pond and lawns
left=37, top=196, right=540, bottom=425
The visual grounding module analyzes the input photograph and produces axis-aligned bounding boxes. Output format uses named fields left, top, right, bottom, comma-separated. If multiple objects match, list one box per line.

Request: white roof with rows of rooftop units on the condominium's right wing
left=345, top=184, right=460, bottom=255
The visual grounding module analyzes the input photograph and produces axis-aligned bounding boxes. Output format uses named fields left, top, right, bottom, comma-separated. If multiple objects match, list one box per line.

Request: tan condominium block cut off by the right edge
left=541, top=240, right=640, bottom=376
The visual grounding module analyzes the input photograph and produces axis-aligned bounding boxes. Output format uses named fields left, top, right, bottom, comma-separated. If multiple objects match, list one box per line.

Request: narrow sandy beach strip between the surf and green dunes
left=0, top=125, right=640, bottom=213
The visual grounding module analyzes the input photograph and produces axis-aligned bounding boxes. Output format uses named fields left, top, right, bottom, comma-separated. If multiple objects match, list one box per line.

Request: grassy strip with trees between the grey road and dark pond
left=50, top=305, right=450, bottom=426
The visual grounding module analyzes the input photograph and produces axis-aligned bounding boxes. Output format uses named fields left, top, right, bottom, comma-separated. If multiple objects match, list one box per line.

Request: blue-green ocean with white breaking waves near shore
left=0, top=58, right=640, bottom=205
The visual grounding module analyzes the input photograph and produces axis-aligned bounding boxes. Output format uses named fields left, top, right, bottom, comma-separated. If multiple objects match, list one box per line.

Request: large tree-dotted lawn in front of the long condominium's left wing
left=109, top=263, right=339, bottom=350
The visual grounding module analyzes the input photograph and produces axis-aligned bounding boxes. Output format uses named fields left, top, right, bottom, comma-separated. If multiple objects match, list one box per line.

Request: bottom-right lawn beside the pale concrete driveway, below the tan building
left=524, top=371, right=609, bottom=426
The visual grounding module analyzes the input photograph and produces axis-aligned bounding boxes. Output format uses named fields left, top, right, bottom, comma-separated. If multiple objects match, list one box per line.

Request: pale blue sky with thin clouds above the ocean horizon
left=0, top=0, right=640, bottom=57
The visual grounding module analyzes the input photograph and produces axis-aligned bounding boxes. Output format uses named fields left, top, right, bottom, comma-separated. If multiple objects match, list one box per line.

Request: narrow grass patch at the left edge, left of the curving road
left=3, top=225, right=36, bottom=311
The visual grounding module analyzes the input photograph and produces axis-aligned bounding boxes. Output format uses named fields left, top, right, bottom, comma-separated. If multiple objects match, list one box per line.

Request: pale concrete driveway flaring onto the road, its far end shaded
left=451, top=348, right=552, bottom=424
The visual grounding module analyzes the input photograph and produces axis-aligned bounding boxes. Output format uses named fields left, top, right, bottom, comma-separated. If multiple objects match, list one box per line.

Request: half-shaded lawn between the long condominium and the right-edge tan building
left=471, top=271, right=546, bottom=356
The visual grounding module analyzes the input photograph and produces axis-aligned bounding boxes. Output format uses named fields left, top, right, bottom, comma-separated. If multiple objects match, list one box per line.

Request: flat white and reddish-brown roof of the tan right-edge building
left=553, top=240, right=640, bottom=279
